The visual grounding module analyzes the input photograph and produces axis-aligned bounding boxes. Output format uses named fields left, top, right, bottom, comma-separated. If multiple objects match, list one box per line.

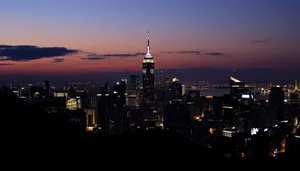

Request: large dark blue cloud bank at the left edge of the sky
left=0, top=45, right=79, bottom=61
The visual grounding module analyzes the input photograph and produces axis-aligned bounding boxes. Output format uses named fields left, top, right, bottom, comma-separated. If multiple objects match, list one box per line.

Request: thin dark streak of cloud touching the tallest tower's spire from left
left=81, top=52, right=145, bottom=60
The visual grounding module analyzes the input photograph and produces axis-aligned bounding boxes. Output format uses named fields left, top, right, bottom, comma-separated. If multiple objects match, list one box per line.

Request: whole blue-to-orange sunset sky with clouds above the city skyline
left=0, top=0, right=300, bottom=83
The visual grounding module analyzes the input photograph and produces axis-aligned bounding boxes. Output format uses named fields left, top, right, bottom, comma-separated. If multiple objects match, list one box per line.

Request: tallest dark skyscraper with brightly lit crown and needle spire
left=143, top=31, right=157, bottom=127
